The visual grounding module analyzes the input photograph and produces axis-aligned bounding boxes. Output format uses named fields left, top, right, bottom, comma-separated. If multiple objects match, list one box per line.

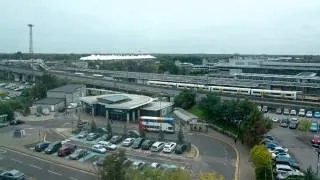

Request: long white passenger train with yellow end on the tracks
left=147, top=81, right=302, bottom=100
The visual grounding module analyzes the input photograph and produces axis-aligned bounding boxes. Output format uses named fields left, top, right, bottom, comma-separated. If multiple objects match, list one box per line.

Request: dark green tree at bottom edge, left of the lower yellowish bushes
left=98, top=149, right=128, bottom=180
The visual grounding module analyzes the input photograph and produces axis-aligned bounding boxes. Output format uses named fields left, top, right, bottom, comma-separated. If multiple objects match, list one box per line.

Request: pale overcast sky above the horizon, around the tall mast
left=0, top=0, right=320, bottom=54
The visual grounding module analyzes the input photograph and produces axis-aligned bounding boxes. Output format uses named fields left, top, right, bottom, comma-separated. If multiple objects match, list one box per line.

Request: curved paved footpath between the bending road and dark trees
left=206, top=129, right=256, bottom=180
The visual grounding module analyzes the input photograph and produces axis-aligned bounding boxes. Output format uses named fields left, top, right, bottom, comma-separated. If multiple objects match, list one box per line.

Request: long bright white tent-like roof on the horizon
left=80, top=54, right=156, bottom=61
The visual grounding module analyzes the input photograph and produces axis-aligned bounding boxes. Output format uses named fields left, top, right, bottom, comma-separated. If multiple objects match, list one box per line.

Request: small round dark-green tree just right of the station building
left=174, top=90, right=196, bottom=109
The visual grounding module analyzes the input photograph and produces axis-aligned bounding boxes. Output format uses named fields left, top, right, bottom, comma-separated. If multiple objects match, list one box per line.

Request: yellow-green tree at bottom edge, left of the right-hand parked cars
left=250, top=144, right=272, bottom=179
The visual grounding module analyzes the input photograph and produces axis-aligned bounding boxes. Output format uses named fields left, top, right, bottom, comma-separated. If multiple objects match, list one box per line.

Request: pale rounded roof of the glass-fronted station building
left=80, top=93, right=153, bottom=109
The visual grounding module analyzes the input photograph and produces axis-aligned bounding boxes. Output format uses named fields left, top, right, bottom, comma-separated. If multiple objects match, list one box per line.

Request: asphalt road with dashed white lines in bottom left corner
left=0, top=149, right=96, bottom=180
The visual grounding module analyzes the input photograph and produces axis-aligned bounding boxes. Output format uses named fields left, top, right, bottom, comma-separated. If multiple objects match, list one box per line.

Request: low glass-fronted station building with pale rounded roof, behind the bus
left=80, top=93, right=173, bottom=123
